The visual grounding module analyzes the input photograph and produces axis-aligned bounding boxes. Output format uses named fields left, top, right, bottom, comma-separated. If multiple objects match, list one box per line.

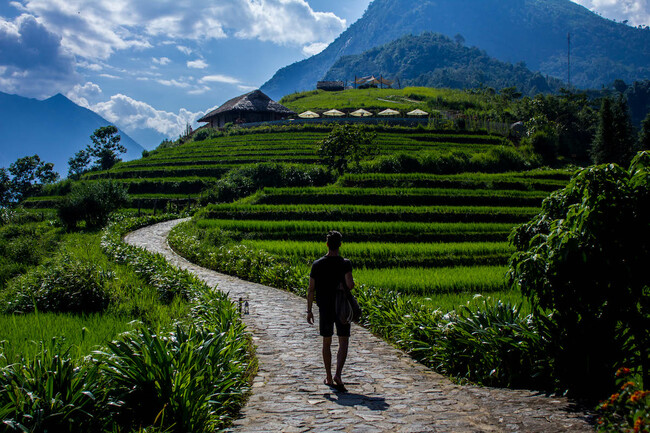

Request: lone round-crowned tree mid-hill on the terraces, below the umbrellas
left=318, top=125, right=377, bottom=174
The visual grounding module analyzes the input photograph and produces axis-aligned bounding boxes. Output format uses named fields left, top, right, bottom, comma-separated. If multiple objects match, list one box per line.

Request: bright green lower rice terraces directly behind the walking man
left=181, top=170, right=570, bottom=306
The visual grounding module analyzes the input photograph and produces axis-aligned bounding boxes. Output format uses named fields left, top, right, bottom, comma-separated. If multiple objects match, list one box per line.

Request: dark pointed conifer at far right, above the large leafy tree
left=591, top=95, right=635, bottom=165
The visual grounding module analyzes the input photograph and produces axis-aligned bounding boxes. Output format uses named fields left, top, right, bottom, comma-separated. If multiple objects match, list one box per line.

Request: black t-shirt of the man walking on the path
left=309, top=256, right=352, bottom=309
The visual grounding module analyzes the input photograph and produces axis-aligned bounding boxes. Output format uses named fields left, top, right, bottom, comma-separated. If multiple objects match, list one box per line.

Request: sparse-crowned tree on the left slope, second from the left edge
left=68, top=125, right=126, bottom=177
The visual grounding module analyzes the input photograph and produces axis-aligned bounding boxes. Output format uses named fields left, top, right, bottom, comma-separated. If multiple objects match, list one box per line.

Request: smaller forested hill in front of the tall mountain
left=325, top=32, right=562, bottom=95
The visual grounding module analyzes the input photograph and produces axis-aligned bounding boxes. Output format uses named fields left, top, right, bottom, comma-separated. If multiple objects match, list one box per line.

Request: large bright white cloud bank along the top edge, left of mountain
left=13, top=0, right=346, bottom=59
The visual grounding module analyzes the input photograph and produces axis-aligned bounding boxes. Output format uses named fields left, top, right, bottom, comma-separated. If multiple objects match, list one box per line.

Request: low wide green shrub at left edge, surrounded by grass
left=2, top=255, right=114, bottom=314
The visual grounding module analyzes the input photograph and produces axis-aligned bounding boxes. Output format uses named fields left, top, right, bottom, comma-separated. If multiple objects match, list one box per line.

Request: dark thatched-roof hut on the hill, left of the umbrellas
left=198, top=90, right=296, bottom=128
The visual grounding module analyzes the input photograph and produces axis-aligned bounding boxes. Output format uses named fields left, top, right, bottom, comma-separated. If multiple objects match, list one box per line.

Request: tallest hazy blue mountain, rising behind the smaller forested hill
left=262, top=0, right=650, bottom=98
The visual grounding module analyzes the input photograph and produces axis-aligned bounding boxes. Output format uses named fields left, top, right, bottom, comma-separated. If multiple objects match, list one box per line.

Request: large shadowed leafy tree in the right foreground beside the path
left=508, top=152, right=650, bottom=397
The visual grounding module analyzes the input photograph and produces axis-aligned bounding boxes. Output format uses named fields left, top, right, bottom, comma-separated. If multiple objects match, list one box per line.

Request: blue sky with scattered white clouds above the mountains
left=0, top=0, right=650, bottom=148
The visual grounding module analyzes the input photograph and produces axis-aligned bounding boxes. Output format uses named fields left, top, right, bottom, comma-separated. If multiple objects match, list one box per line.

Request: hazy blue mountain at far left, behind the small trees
left=0, top=92, right=144, bottom=176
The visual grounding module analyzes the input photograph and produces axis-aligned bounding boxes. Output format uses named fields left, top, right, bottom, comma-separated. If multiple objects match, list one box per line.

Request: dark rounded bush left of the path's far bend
left=58, top=180, right=129, bottom=229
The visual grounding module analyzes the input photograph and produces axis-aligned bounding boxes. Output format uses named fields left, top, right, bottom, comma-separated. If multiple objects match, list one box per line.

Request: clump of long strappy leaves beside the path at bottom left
left=95, top=318, right=249, bottom=433
